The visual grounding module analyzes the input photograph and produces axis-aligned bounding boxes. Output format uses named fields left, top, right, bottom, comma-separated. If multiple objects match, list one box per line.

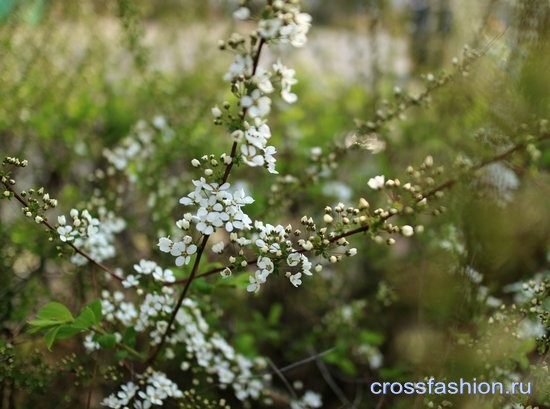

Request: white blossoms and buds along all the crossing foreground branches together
left=2, top=0, right=548, bottom=409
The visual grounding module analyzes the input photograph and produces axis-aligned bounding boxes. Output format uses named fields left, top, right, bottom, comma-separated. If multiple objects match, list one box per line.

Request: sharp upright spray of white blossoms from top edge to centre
left=158, top=1, right=312, bottom=302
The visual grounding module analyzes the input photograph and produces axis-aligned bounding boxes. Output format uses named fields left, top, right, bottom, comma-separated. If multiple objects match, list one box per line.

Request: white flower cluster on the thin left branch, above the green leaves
left=56, top=207, right=126, bottom=266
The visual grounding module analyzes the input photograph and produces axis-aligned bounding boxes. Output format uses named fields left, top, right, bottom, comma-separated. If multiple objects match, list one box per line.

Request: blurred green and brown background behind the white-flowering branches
left=0, top=0, right=550, bottom=409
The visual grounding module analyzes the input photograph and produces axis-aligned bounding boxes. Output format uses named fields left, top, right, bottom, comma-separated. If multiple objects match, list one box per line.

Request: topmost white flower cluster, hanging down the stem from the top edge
left=217, top=0, right=311, bottom=173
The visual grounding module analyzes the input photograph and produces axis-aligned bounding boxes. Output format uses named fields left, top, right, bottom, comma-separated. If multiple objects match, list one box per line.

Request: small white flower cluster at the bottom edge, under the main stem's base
left=101, top=368, right=183, bottom=409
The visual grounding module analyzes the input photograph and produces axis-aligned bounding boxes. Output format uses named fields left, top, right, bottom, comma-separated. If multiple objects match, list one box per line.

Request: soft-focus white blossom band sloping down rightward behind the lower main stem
left=98, top=284, right=274, bottom=407
